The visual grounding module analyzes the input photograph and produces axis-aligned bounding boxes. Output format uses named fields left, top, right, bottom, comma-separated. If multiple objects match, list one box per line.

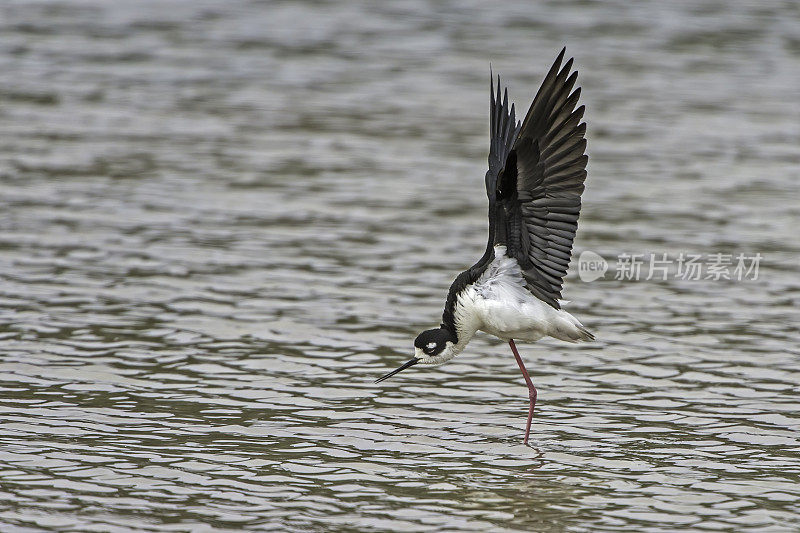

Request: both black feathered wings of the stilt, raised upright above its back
left=486, top=49, right=588, bottom=309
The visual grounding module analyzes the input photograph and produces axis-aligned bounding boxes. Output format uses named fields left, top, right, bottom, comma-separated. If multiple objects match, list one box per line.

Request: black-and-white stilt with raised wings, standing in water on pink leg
left=376, top=49, right=594, bottom=444
